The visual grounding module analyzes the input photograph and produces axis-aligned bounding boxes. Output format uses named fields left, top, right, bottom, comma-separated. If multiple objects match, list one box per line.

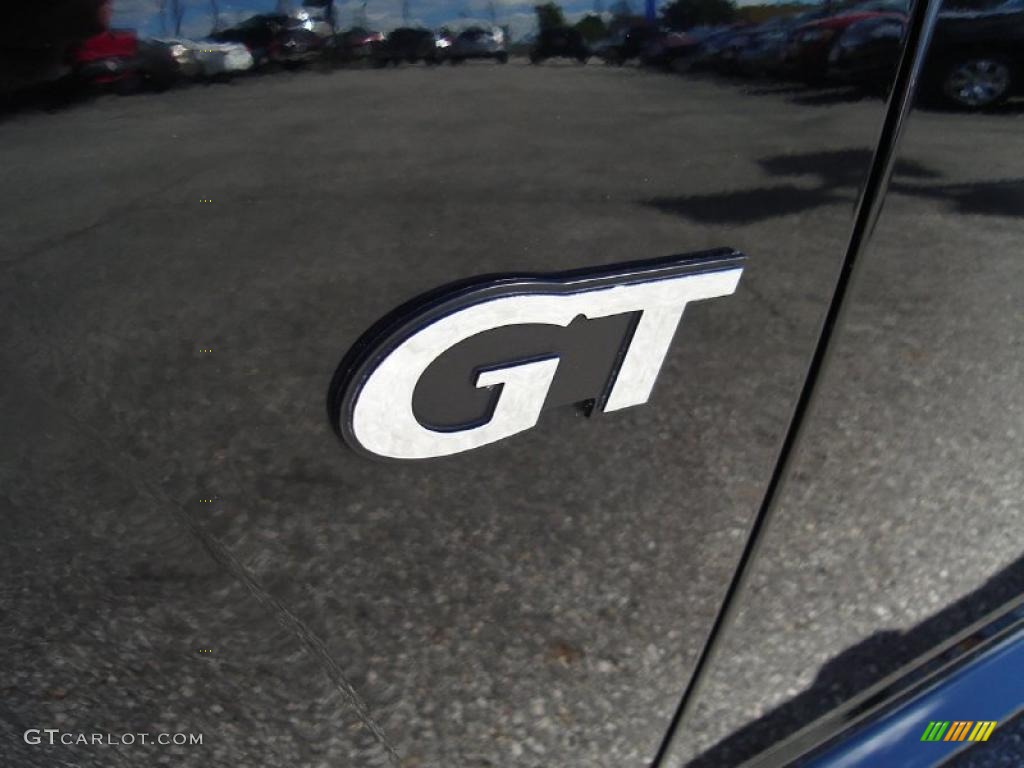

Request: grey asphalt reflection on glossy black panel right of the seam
left=669, top=1, right=1024, bottom=766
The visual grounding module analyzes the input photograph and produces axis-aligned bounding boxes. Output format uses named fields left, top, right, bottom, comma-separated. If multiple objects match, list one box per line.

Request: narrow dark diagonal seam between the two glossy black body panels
left=651, top=0, right=942, bottom=768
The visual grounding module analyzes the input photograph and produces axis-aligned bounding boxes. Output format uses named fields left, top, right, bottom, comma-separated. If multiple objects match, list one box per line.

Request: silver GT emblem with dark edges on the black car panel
left=328, top=249, right=743, bottom=459
